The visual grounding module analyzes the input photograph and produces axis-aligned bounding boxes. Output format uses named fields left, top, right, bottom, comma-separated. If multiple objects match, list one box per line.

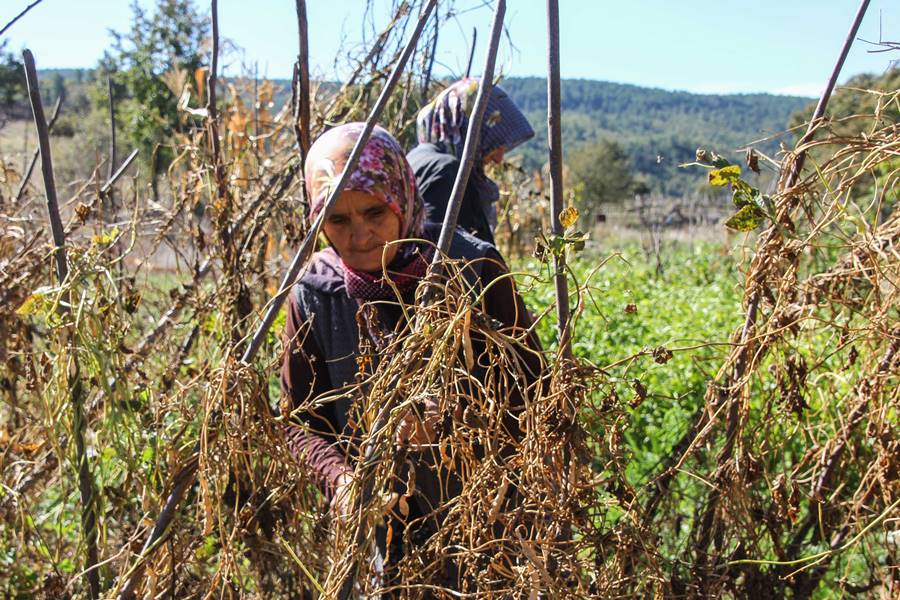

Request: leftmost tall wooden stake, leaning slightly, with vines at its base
left=22, top=49, right=100, bottom=598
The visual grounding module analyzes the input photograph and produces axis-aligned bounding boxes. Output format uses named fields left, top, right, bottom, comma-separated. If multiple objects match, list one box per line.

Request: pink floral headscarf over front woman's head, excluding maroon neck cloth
left=306, top=123, right=425, bottom=238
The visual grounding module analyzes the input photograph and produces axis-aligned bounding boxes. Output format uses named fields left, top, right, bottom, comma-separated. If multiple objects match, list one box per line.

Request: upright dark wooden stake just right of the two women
left=547, top=0, right=572, bottom=359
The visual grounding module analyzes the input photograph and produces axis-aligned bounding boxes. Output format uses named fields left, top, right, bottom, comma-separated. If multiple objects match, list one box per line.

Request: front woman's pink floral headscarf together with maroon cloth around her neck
left=306, top=123, right=430, bottom=300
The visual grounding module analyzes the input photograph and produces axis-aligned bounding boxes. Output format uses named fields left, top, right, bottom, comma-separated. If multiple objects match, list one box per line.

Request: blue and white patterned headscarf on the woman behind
left=416, top=77, right=534, bottom=162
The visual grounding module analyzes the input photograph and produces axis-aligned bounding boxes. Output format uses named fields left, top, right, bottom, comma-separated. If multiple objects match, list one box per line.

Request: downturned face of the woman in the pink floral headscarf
left=322, top=191, right=400, bottom=272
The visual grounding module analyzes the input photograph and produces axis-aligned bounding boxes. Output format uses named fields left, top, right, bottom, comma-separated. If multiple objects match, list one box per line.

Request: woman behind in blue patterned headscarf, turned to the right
left=407, top=78, right=534, bottom=244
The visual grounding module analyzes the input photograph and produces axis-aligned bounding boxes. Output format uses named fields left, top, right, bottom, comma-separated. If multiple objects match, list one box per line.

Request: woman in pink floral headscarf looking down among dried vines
left=281, top=123, right=541, bottom=584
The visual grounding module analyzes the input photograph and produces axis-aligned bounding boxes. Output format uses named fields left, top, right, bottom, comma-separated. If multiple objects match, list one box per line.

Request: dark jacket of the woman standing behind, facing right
left=406, top=143, right=494, bottom=244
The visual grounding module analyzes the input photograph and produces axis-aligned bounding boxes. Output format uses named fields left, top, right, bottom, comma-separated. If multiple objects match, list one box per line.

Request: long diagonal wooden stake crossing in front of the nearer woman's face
left=118, top=0, right=437, bottom=600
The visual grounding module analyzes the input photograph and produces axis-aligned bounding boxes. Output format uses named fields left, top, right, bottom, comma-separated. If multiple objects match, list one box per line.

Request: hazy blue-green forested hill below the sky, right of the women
left=501, top=77, right=810, bottom=195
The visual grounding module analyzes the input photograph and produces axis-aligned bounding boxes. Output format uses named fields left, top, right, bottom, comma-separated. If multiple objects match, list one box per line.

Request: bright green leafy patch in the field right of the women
left=515, top=242, right=742, bottom=484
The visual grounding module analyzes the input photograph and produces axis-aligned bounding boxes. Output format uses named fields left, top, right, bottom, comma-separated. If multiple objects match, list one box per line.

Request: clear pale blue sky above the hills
left=0, top=0, right=900, bottom=96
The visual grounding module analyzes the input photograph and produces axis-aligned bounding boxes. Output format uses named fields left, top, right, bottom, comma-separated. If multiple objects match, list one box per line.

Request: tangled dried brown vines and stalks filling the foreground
left=0, top=16, right=900, bottom=598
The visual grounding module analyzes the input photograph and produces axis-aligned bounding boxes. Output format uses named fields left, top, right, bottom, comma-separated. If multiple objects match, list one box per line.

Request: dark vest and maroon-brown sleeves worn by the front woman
left=281, top=225, right=541, bottom=495
